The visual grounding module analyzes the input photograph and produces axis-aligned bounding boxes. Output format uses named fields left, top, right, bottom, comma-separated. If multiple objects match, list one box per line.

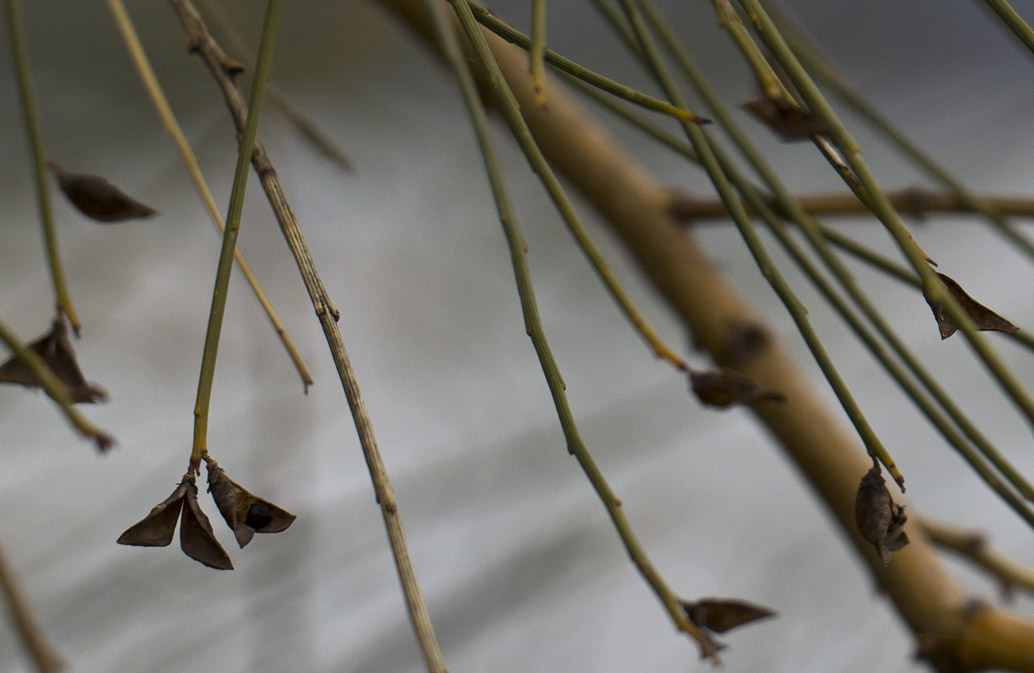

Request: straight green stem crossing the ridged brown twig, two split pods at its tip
left=190, top=0, right=283, bottom=472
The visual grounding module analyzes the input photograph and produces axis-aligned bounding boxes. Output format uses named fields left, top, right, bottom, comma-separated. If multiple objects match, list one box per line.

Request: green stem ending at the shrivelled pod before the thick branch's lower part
left=620, top=0, right=905, bottom=491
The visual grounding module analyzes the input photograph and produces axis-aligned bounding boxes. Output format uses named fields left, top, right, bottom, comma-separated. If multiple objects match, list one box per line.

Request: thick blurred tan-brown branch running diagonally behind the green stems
left=387, top=0, right=1034, bottom=671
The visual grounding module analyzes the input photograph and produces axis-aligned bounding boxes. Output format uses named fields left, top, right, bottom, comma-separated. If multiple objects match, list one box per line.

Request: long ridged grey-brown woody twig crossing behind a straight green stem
left=170, top=0, right=447, bottom=673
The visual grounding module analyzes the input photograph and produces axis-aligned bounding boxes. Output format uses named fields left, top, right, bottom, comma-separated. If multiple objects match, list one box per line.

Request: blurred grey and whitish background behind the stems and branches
left=0, top=0, right=1034, bottom=673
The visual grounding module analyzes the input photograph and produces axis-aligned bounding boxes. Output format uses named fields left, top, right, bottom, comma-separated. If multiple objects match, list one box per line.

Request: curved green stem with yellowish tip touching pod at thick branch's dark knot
left=444, top=0, right=690, bottom=372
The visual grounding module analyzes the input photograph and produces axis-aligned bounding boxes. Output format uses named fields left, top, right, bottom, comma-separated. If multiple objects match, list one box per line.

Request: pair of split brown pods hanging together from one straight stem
left=118, top=455, right=295, bottom=571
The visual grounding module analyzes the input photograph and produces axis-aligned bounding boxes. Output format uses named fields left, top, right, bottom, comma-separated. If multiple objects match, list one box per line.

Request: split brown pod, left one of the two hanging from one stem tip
left=118, top=472, right=234, bottom=571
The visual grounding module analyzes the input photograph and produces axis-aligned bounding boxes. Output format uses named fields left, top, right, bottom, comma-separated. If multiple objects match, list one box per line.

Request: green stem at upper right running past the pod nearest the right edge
left=740, top=0, right=1034, bottom=436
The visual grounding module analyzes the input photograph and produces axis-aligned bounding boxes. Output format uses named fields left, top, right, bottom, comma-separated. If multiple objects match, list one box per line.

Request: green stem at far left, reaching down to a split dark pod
left=7, top=0, right=82, bottom=336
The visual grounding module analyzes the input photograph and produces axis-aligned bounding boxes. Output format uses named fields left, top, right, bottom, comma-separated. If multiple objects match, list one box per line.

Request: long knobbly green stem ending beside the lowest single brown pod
left=426, top=0, right=719, bottom=662
